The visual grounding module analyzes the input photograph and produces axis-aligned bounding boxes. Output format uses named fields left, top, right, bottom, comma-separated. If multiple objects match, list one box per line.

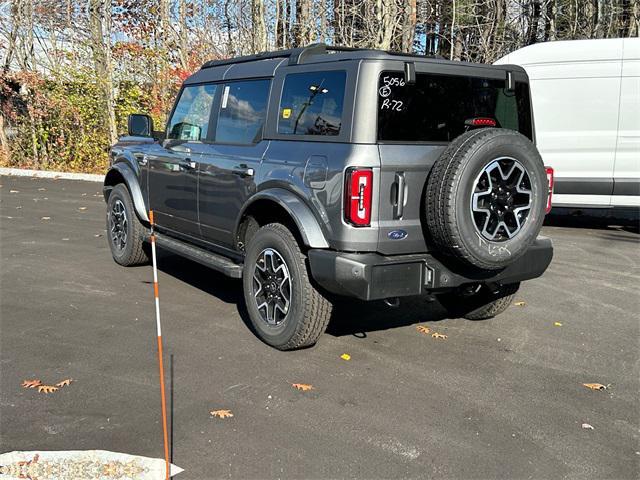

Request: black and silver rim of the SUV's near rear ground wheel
left=253, top=248, right=291, bottom=326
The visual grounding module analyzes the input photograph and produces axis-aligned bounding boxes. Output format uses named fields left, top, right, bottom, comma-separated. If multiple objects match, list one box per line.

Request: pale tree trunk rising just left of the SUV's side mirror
left=89, top=0, right=118, bottom=144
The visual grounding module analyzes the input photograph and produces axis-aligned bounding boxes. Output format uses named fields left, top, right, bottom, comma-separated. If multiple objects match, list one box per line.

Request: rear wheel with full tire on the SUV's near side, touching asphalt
left=242, top=223, right=332, bottom=350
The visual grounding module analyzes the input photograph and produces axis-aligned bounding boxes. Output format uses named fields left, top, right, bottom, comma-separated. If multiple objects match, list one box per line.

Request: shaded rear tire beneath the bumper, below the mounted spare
left=438, top=283, right=520, bottom=320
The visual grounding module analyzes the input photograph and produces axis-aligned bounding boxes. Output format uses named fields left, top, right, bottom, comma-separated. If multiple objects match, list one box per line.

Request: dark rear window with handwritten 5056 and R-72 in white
left=378, top=72, right=532, bottom=142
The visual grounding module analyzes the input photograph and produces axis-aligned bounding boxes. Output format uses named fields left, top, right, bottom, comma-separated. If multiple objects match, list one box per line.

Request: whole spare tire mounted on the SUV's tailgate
left=425, top=128, right=549, bottom=270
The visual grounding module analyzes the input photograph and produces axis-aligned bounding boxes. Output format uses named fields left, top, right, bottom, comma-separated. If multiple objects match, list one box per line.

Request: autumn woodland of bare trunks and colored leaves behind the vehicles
left=0, top=0, right=640, bottom=173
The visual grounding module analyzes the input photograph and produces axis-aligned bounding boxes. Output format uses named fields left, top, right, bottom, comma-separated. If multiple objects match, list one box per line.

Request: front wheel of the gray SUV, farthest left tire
left=107, top=183, right=149, bottom=267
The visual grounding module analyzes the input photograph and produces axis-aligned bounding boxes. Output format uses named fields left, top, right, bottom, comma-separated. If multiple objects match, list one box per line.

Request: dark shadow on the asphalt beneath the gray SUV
left=158, top=250, right=450, bottom=338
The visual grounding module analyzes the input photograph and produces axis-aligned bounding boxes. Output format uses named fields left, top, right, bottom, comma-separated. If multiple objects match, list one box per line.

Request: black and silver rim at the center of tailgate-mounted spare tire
left=471, top=157, right=532, bottom=242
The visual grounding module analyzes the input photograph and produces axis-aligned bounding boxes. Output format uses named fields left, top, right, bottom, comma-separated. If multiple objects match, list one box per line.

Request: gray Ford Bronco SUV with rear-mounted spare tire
left=104, top=44, right=553, bottom=350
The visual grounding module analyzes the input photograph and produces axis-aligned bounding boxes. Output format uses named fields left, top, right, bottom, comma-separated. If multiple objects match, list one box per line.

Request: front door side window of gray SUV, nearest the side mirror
left=167, top=85, right=216, bottom=142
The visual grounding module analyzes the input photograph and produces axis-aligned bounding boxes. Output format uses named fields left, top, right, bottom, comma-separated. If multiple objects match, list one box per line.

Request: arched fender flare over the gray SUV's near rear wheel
left=239, top=188, right=329, bottom=248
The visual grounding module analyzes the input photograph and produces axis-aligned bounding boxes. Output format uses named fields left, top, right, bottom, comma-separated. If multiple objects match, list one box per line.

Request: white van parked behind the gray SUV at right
left=496, top=38, right=640, bottom=210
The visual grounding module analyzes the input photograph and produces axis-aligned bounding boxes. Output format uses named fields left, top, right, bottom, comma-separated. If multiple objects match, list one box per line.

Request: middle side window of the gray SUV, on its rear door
left=215, top=80, right=270, bottom=145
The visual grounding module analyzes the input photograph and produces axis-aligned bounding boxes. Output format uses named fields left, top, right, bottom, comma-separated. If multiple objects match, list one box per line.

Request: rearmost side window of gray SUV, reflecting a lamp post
left=278, top=70, right=347, bottom=135
